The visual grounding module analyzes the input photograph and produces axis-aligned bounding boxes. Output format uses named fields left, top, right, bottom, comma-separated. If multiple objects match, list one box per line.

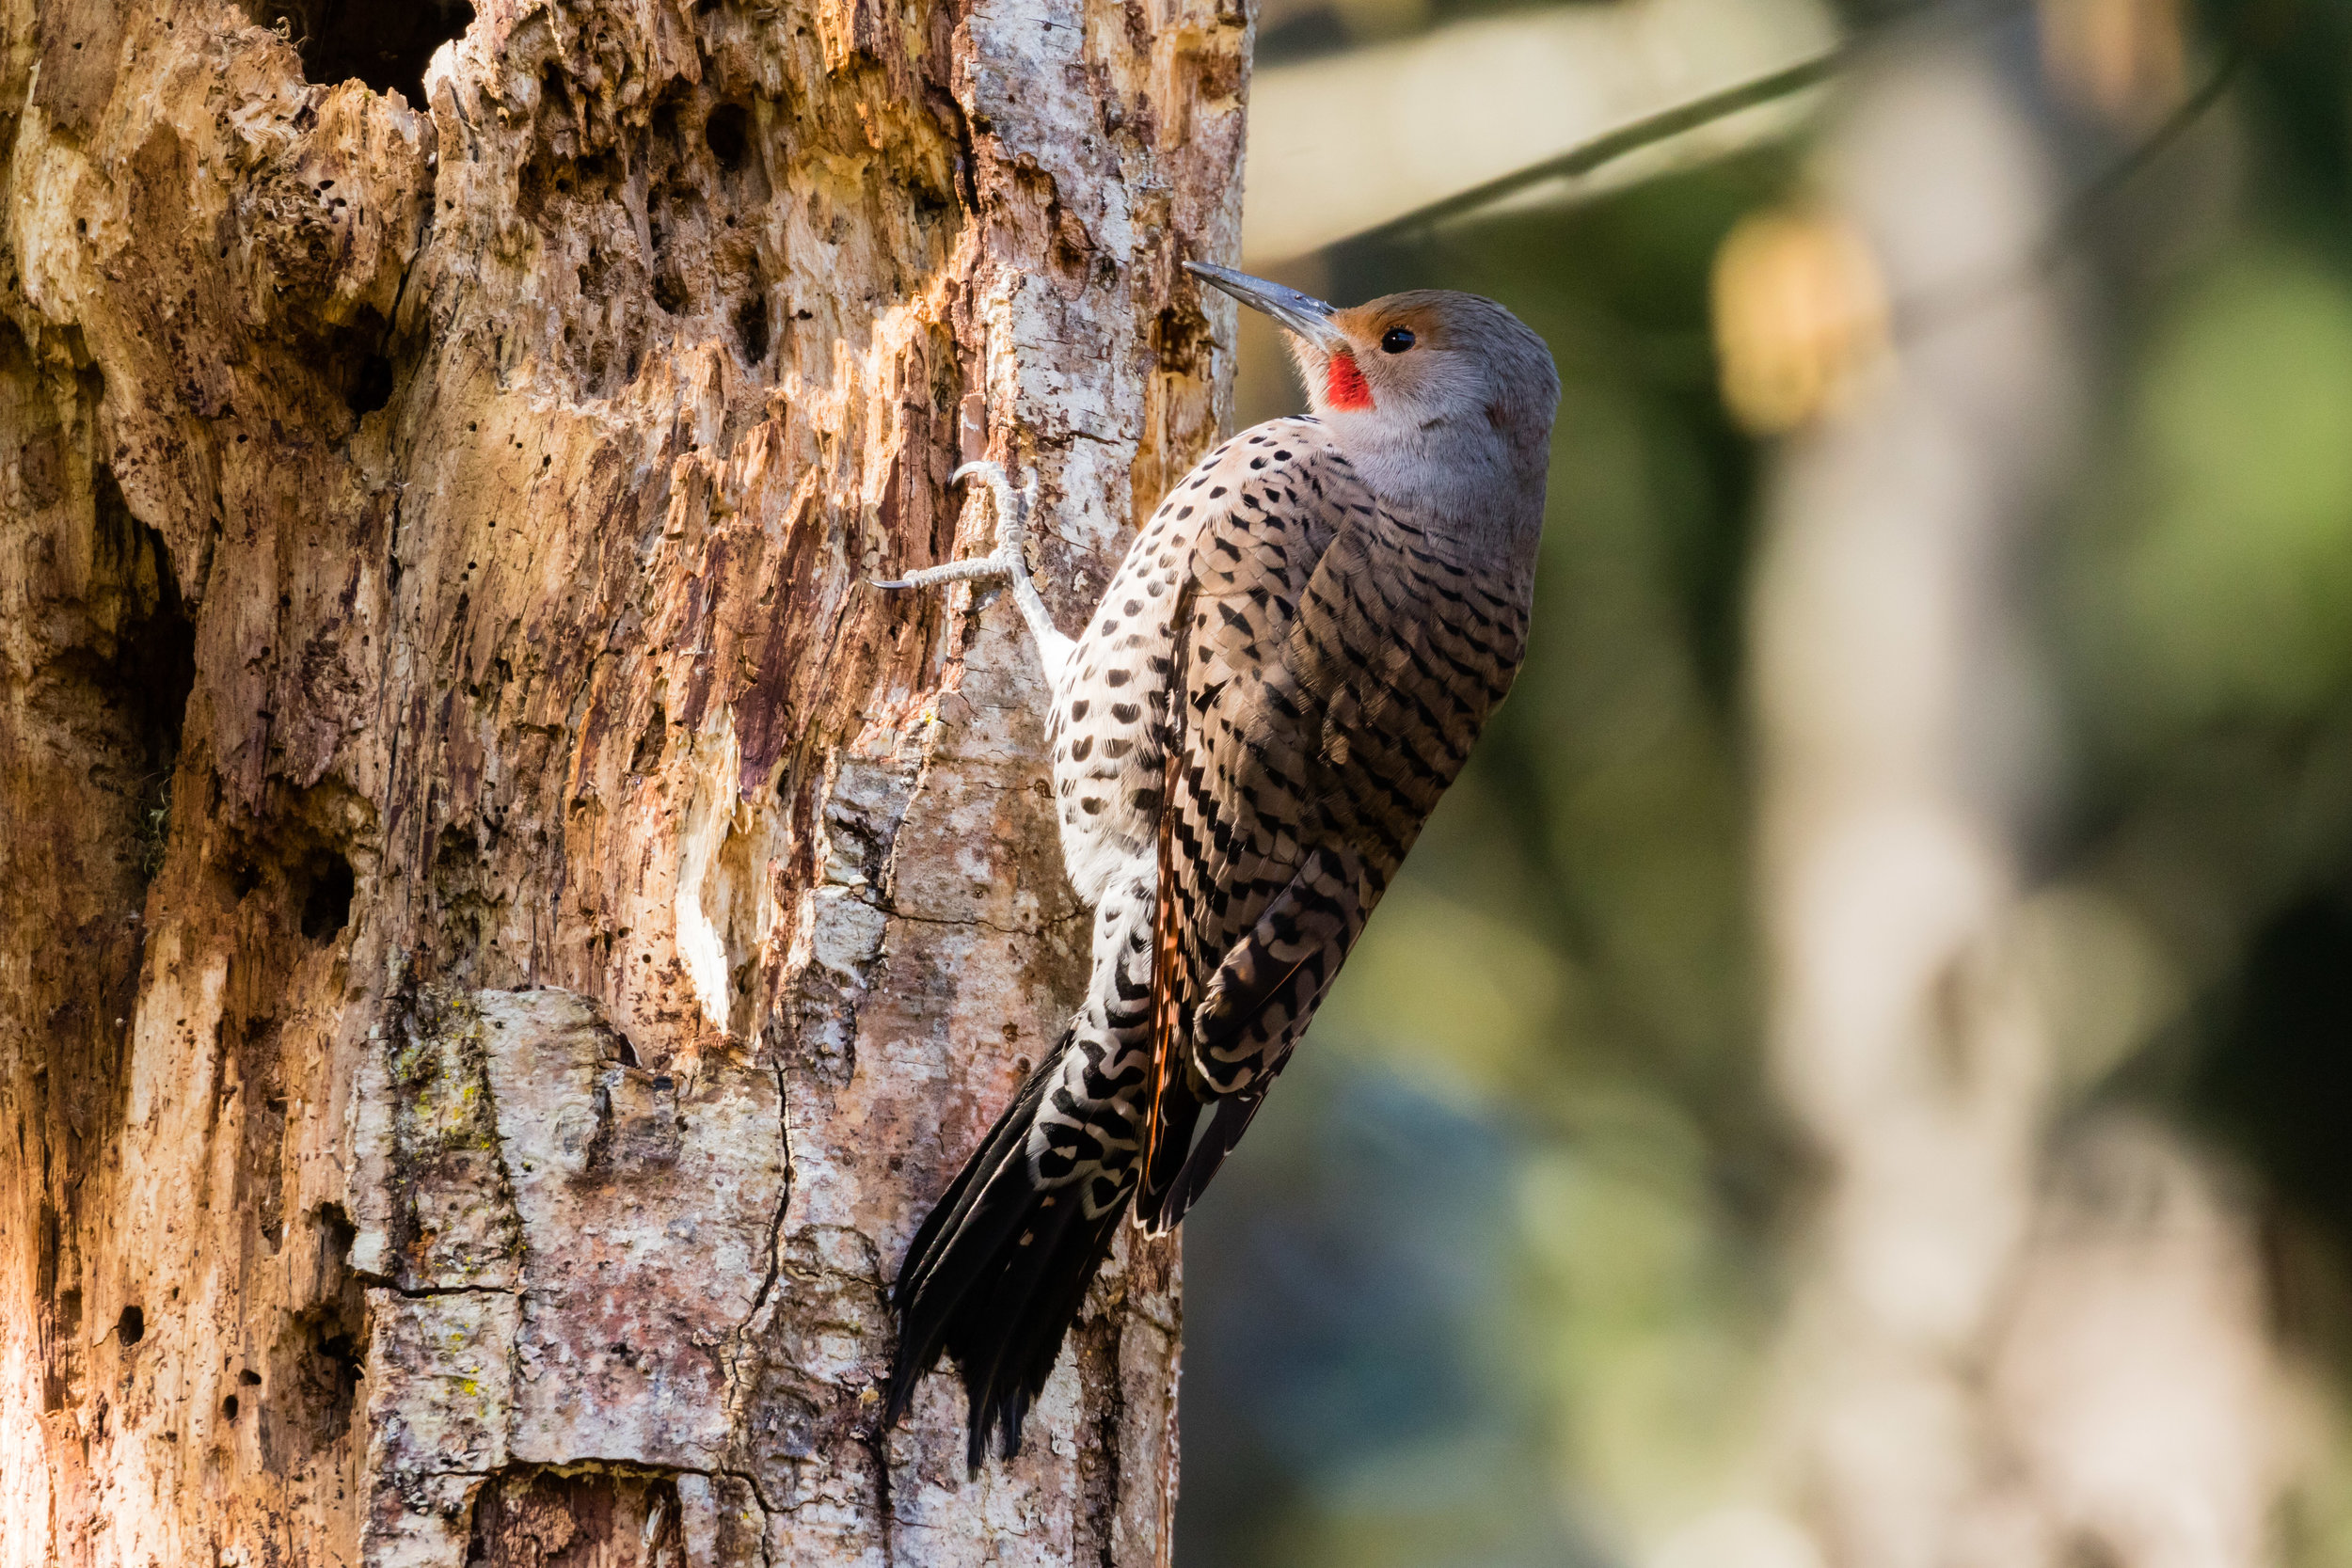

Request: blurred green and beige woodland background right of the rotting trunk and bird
left=1179, top=0, right=2352, bottom=1568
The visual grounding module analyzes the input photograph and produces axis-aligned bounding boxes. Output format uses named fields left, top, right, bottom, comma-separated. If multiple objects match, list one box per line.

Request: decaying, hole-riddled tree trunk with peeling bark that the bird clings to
left=0, top=0, right=1247, bottom=1568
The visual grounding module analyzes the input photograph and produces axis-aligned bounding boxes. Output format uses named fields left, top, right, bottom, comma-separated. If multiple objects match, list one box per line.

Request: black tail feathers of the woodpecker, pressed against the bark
left=882, top=1051, right=1127, bottom=1474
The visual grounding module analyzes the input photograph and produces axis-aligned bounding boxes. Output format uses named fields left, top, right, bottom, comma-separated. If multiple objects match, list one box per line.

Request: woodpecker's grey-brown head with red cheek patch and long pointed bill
left=1185, top=261, right=1560, bottom=543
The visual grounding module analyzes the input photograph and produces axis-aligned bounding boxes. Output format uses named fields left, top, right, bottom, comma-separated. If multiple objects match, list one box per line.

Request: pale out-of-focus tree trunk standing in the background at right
left=1753, top=30, right=2280, bottom=1568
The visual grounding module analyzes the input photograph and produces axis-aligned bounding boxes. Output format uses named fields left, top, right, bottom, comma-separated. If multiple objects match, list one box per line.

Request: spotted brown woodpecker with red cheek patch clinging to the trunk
left=880, top=263, right=1560, bottom=1472
